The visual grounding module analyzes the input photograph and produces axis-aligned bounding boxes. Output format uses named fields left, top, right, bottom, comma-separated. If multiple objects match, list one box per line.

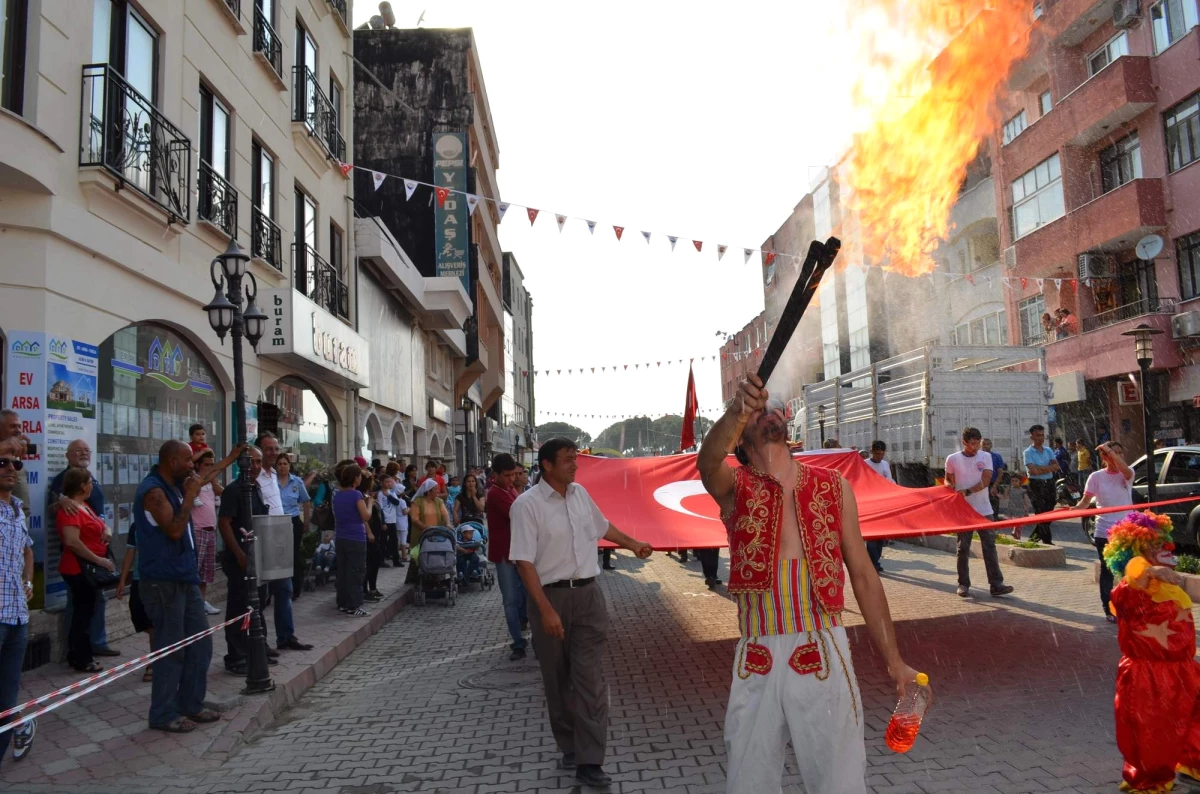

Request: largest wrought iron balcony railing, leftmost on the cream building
left=79, top=64, right=192, bottom=223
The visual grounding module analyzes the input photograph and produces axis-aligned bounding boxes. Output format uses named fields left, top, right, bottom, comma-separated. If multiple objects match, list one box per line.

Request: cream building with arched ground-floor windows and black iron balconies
left=0, top=0, right=360, bottom=604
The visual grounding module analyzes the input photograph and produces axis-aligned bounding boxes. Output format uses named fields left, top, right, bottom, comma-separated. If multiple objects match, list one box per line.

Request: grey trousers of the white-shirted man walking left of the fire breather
left=529, top=582, right=608, bottom=765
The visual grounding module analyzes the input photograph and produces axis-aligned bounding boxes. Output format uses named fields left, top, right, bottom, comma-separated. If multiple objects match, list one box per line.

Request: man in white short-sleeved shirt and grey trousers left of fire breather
left=509, top=438, right=650, bottom=786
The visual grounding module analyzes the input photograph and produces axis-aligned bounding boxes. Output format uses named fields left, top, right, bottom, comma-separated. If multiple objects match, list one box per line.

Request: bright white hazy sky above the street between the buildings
left=354, top=0, right=864, bottom=434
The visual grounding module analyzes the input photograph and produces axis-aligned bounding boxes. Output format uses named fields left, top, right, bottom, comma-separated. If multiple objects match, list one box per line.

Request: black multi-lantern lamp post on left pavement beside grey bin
left=204, top=240, right=275, bottom=694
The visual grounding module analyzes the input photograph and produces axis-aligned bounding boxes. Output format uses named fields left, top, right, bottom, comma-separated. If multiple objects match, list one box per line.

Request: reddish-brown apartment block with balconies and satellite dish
left=992, top=0, right=1200, bottom=455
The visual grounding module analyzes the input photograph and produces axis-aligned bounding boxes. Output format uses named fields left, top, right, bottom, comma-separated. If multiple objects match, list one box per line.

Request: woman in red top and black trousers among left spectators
left=56, top=469, right=115, bottom=673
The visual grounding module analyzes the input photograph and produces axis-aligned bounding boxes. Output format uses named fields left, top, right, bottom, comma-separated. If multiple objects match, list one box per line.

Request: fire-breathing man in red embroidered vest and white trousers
left=696, top=374, right=917, bottom=794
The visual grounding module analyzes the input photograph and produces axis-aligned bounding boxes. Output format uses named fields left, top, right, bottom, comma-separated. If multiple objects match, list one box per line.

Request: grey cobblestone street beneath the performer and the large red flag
left=6, top=524, right=1142, bottom=794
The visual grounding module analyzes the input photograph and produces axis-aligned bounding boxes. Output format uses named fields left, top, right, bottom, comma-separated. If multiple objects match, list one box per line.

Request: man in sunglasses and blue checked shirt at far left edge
left=0, top=455, right=37, bottom=760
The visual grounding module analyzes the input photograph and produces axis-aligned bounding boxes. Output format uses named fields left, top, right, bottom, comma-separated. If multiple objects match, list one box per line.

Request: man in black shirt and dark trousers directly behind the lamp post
left=217, top=446, right=280, bottom=675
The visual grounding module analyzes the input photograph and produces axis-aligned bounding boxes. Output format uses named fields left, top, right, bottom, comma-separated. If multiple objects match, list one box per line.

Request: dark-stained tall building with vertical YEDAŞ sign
left=354, top=28, right=511, bottom=465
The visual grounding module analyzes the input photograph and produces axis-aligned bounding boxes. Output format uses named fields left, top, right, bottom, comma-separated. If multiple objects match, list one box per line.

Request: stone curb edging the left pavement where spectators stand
left=203, top=585, right=413, bottom=760
